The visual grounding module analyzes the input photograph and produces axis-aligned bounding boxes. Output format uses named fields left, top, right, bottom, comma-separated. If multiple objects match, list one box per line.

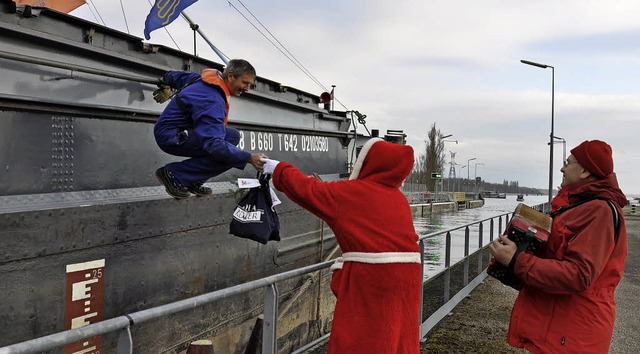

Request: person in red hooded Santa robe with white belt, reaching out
left=262, top=138, right=422, bottom=354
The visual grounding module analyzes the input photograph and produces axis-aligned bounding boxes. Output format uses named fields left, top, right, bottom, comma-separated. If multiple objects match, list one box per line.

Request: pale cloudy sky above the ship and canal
left=71, top=0, right=640, bottom=196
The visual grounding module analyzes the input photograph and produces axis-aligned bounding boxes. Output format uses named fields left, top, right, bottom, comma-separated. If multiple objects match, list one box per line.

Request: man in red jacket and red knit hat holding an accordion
left=489, top=140, right=628, bottom=353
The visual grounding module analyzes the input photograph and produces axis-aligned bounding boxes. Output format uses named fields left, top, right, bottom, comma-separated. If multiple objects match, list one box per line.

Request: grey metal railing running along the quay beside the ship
left=0, top=206, right=543, bottom=354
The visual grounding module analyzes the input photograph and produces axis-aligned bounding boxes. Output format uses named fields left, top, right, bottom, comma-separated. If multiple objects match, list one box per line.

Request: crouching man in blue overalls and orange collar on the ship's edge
left=154, top=59, right=266, bottom=199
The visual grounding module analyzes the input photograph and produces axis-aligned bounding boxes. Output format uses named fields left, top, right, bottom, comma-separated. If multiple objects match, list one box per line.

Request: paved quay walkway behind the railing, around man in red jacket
left=421, top=210, right=640, bottom=354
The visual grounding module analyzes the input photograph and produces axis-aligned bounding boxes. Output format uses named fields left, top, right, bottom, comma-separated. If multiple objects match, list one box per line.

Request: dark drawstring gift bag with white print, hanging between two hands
left=229, top=173, right=280, bottom=244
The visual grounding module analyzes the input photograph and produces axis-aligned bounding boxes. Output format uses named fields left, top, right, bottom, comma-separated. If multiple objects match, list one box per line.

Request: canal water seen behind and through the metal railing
left=414, top=195, right=549, bottom=278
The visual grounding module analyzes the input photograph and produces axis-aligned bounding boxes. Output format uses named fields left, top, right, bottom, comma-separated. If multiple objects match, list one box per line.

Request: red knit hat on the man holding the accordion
left=571, top=140, right=613, bottom=178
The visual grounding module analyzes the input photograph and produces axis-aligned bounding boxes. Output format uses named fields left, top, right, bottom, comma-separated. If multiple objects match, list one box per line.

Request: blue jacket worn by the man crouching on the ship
left=156, top=71, right=251, bottom=165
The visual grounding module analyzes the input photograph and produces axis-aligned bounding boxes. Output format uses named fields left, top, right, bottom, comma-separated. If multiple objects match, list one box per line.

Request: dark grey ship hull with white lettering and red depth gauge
left=0, top=2, right=352, bottom=353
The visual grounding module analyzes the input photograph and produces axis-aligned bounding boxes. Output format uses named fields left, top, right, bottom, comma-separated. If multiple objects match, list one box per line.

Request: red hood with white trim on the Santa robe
left=349, top=138, right=414, bottom=188
